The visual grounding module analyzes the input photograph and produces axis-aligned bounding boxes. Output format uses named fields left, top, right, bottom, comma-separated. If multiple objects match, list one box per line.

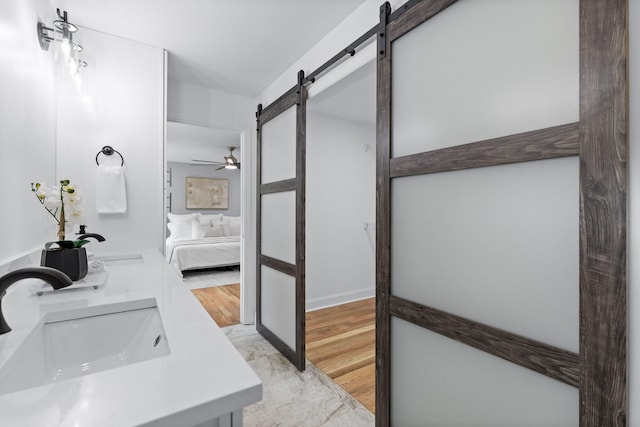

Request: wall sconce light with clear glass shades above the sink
left=37, top=9, right=87, bottom=74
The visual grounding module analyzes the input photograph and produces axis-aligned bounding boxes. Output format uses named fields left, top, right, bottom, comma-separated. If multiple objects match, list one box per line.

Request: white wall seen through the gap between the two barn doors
left=306, top=112, right=376, bottom=310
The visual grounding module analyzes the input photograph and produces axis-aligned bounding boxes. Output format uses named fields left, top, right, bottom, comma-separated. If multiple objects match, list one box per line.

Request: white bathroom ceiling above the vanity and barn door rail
left=53, top=0, right=365, bottom=97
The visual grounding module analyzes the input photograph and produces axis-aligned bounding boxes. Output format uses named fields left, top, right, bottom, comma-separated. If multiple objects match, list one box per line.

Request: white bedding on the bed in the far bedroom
left=166, top=236, right=240, bottom=272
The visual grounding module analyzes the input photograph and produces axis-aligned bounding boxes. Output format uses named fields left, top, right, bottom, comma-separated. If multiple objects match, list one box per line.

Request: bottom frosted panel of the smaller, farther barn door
left=260, top=265, right=296, bottom=348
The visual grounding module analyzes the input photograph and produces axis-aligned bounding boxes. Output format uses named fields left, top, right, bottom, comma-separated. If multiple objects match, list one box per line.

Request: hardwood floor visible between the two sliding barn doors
left=306, top=298, right=376, bottom=413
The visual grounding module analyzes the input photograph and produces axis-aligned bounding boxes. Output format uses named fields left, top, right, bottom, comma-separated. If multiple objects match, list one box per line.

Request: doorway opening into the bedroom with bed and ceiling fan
left=165, top=121, right=243, bottom=327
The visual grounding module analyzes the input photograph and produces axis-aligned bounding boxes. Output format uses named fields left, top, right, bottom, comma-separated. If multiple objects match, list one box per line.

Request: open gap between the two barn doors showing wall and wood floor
left=305, top=61, right=376, bottom=413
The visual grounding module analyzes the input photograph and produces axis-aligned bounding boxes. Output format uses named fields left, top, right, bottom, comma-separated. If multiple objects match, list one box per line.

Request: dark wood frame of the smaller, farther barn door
left=256, top=71, right=307, bottom=371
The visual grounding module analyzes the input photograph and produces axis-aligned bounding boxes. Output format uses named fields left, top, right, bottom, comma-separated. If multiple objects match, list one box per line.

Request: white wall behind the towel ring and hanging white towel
left=57, top=28, right=164, bottom=252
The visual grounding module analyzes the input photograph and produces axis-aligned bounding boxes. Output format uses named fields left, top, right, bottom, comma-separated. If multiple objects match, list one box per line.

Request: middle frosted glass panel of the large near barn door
left=391, top=157, right=579, bottom=352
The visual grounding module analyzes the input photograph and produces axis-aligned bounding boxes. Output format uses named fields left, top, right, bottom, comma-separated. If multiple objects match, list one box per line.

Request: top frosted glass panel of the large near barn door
left=391, top=0, right=579, bottom=157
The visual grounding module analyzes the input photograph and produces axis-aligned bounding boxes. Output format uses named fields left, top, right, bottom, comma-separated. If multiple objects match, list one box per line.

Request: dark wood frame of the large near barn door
left=376, top=0, right=628, bottom=427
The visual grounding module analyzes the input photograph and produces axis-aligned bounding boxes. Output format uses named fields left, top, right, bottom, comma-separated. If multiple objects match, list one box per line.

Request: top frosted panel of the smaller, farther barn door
left=261, top=106, right=296, bottom=184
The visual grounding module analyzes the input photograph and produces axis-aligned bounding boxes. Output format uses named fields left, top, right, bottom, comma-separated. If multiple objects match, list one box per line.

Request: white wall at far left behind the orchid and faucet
left=0, top=0, right=56, bottom=273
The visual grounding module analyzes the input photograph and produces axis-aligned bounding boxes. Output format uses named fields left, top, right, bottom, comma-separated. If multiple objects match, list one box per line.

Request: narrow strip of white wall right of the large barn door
left=627, top=0, right=640, bottom=427
